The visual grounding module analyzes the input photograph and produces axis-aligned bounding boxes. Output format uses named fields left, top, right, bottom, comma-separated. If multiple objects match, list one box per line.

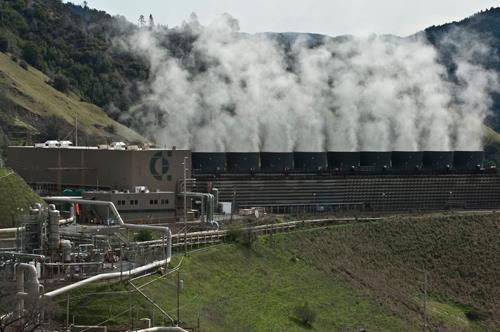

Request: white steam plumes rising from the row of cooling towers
left=123, top=15, right=498, bottom=151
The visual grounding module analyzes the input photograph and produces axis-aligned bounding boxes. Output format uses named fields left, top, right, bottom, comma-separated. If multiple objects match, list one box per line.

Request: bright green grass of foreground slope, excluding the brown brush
left=61, top=239, right=411, bottom=331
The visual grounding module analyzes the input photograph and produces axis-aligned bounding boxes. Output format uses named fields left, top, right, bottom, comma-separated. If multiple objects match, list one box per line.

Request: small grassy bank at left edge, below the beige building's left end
left=0, top=168, right=42, bottom=228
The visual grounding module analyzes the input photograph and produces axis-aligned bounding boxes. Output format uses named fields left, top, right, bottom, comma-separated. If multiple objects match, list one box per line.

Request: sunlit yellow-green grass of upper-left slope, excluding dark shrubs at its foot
left=0, top=52, right=145, bottom=141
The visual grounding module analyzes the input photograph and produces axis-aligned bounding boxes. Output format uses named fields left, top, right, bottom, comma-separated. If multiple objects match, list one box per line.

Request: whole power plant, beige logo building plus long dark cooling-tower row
left=7, top=146, right=500, bottom=219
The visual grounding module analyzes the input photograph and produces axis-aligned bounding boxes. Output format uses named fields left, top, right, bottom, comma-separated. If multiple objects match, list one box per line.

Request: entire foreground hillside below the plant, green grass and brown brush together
left=53, top=214, right=500, bottom=331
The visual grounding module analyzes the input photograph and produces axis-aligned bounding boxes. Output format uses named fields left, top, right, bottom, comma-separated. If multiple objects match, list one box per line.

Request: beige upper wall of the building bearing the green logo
left=7, top=147, right=191, bottom=191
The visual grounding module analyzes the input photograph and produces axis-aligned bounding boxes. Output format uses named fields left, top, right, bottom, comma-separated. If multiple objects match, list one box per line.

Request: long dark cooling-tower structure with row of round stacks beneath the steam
left=192, top=151, right=500, bottom=213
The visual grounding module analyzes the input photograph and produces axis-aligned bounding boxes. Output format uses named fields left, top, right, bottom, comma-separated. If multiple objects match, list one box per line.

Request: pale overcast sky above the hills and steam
left=82, top=0, right=500, bottom=36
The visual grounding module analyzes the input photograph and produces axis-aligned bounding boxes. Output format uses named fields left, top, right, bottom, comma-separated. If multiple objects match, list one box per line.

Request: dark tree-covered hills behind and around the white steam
left=0, top=0, right=500, bottom=160
